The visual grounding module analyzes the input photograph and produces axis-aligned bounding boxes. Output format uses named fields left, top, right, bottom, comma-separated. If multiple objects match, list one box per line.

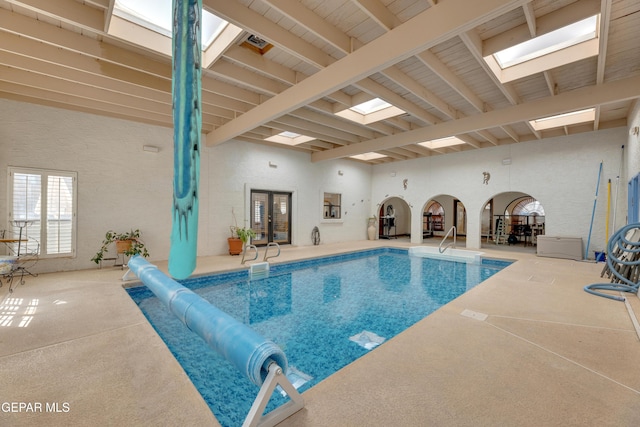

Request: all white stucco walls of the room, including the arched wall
left=0, top=100, right=640, bottom=272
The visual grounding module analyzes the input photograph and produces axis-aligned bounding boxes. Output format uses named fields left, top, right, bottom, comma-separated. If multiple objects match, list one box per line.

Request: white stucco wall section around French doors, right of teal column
left=201, top=141, right=371, bottom=254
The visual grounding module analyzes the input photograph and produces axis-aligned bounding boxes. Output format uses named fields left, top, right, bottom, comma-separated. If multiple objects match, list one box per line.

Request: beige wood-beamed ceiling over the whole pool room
left=0, top=0, right=640, bottom=163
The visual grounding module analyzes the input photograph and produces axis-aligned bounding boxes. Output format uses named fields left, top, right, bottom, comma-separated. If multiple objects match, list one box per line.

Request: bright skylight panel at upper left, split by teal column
left=109, top=0, right=234, bottom=54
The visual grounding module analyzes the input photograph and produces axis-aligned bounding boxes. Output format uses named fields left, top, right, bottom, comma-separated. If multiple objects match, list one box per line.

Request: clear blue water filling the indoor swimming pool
left=128, top=248, right=510, bottom=427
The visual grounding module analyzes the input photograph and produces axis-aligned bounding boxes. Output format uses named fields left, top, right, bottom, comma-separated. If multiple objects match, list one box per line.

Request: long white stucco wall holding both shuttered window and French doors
left=0, top=100, right=372, bottom=272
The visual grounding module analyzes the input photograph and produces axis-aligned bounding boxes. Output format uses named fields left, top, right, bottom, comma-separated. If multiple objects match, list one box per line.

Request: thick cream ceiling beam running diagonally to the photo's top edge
left=205, top=0, right=526, bottom=146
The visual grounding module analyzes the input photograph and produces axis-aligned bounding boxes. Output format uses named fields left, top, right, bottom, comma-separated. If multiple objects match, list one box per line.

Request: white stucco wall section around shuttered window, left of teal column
left=0, top=100, right=178, bottom=272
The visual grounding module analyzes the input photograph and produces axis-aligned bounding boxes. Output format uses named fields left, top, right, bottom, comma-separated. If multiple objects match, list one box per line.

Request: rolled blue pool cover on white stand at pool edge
left=129, top=256, right=287, bottom=386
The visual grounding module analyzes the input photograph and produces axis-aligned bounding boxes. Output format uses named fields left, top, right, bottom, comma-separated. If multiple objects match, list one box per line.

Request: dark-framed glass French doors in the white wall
left=251, top=190, right=291, bottom=246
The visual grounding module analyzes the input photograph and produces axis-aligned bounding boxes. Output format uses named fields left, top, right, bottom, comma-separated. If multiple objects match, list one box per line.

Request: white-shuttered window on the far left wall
left=8, top=167, right=77, bottom=257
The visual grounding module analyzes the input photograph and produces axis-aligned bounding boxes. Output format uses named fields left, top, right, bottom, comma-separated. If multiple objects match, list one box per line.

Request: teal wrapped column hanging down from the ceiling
left=169, top=0, right=202, bottom=279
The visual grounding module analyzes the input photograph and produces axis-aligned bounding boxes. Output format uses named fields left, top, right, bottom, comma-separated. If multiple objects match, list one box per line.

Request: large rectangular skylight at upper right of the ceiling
left=484, top=15, right=600, bottom=83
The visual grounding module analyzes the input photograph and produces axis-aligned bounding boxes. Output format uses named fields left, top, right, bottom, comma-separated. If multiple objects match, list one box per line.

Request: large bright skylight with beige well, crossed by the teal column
left=109, top=0, right=241, bottom=66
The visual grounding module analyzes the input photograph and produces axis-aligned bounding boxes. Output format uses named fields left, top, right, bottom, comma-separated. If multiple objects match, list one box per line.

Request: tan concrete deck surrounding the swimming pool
left=0, top=239, right=640, bottom=427
